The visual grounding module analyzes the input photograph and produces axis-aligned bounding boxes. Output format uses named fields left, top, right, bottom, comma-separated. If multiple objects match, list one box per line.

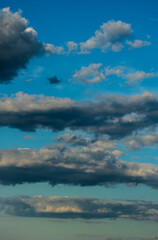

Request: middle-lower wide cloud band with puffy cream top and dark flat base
left=0, top=139, right=158, bottom=188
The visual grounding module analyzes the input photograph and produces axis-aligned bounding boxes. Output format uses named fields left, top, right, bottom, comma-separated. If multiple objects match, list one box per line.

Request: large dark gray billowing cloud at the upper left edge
left=0, top=8, right=53, bottom=83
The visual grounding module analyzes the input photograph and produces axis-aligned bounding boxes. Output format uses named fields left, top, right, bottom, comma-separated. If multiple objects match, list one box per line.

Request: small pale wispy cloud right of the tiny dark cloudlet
left=72, top=63, right=105, bottom=84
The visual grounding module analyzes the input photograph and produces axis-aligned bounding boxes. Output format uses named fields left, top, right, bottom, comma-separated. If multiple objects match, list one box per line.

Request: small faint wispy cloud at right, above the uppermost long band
left=124, top=71, right=156, bottom=86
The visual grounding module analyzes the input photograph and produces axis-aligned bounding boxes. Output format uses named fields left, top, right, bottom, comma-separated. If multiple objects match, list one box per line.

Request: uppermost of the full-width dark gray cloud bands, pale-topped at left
left=0, top=92, right=158, bottom=138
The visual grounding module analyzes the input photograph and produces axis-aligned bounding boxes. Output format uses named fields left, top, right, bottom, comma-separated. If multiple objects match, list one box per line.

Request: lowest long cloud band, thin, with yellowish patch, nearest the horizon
left=0, top=196, right=158, bottom=221
